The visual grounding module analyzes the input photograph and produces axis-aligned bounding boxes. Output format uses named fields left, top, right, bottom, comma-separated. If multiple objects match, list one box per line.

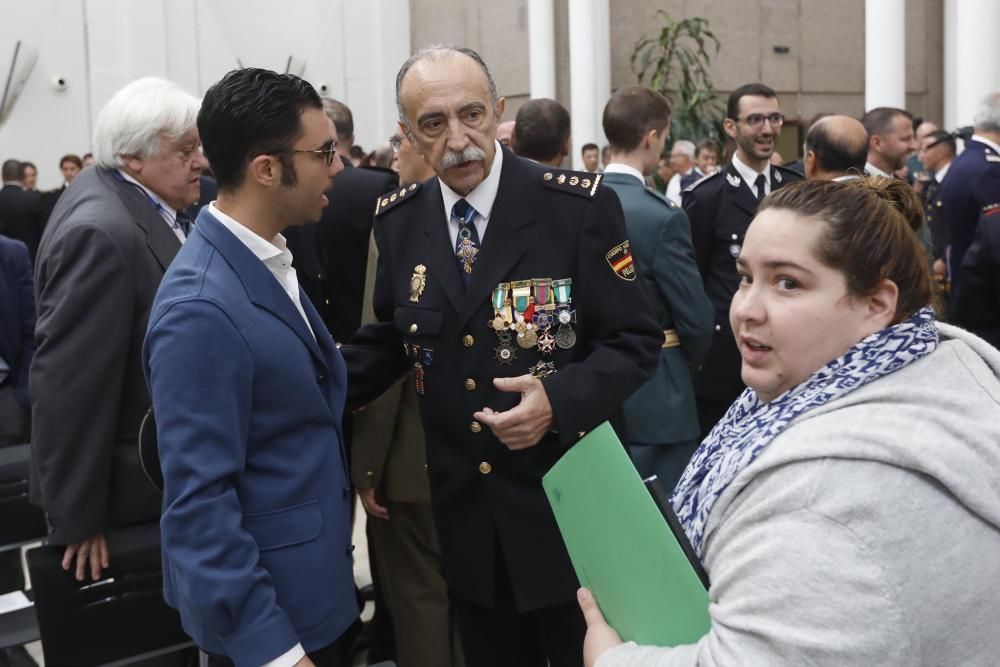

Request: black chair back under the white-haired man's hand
left=27, top=523, right=191, bottom=665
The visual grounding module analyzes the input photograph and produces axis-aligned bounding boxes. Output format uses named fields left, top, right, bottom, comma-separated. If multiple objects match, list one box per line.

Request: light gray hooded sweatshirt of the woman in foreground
left=596, top=324, right=1000, bottom=667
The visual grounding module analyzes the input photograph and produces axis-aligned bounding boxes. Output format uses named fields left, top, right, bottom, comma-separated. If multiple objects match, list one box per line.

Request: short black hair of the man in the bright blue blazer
left=198, top=67, right=323, bottom=190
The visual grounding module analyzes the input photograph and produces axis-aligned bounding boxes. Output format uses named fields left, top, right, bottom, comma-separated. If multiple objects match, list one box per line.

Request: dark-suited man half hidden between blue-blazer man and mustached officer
left=304, top=98, right=398, bottom=342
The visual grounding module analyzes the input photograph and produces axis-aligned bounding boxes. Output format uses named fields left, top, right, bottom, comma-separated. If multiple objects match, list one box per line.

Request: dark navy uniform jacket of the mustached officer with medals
left=343, top=149, right=663, bottom=611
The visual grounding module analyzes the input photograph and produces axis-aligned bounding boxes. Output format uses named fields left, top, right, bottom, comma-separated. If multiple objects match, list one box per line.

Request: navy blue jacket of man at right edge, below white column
left=937, top=140, right=1000, bottom=301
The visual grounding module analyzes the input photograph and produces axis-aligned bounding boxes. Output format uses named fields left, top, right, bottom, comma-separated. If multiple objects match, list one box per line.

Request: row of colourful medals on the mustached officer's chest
left=487, top=278, right=576, bottom=375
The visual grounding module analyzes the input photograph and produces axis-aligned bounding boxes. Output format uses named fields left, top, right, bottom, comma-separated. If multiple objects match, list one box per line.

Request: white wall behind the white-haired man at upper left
left=0, top=0, right=410, bottom=189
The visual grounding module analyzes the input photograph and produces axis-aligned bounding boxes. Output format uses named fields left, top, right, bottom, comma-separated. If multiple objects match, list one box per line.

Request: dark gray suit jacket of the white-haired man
left=29, top=168, right=180, bottom=544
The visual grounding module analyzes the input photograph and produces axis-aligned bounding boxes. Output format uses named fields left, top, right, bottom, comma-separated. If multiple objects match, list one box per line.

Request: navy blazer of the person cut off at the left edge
left=0, top=236, right=35, bottom=410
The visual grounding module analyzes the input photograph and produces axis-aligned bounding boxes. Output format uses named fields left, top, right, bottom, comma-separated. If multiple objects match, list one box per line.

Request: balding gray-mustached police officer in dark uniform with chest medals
left=345, top=47, right=663, bottom=667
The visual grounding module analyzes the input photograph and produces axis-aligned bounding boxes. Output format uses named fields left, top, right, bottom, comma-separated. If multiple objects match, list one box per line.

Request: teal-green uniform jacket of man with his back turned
left=604, top=173, right=714, bottom=445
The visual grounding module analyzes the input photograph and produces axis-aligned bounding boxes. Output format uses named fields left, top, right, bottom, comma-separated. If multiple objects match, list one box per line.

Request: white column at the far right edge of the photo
left=944, top=0, right=1000, bottom=129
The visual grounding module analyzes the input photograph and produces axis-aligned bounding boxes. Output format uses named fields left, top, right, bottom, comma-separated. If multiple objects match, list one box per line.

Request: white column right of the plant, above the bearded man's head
left=865, top=0, right=906, bottom=111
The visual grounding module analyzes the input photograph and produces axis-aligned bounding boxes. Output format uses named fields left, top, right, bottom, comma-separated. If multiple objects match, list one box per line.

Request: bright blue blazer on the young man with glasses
left=143, top=208, right=358, bottom=667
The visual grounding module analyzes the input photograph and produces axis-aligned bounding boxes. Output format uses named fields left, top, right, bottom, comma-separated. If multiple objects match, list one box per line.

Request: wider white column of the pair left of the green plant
left=569, top=0, right=611, bottom=169
